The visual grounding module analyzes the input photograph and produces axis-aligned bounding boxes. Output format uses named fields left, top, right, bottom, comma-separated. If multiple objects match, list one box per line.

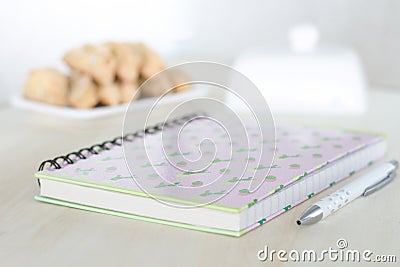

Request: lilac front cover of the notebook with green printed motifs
left=40, top=120, right=382, bottom=209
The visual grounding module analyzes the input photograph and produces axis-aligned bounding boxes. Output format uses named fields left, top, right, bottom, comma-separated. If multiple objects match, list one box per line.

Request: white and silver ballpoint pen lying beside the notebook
left=296, top=160, right=399, bottom=225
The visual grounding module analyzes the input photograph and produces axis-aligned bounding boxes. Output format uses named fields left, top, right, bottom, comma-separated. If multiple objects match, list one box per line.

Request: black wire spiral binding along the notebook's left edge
left=38, top=113, right=205, bottom=177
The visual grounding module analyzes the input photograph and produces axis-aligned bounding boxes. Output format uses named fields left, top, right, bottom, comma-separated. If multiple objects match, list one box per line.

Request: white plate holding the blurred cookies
left=11, top=88, right=207, bottom=119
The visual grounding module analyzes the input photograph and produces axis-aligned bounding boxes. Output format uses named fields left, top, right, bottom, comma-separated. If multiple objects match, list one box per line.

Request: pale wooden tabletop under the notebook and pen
left=0, top=90, right=400, bottom=266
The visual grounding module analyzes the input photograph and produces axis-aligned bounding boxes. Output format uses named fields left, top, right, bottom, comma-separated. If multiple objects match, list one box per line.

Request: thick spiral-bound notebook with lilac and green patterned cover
left=35, top=114, right=386, bottom=236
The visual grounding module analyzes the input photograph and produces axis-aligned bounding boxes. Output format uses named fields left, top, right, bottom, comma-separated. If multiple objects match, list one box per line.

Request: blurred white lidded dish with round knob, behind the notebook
left=231, top=23, right=366, bottom=114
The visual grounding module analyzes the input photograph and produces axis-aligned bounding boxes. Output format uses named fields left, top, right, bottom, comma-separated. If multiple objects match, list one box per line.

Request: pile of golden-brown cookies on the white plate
left=24, top=42, right=188, bottom=109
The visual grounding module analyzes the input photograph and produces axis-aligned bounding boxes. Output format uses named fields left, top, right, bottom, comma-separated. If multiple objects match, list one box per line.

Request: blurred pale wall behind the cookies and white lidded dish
left=0, top=0, right=400, bottom=111
